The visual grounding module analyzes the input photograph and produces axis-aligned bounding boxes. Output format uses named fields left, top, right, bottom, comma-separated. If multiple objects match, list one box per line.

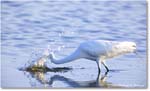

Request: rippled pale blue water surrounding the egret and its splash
left=1, top=0, right=147, bottom=88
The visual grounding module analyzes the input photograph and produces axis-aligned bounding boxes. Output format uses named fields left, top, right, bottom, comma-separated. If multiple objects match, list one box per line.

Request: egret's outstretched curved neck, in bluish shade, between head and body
left=51, top=50, right=81, bottom=64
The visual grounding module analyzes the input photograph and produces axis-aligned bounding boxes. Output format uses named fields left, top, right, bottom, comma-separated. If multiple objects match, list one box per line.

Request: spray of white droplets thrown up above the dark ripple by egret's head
left=21, top=44, right=65, bottom=70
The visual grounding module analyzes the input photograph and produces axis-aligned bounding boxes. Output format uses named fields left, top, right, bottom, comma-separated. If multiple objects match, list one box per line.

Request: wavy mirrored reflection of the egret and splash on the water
left=24, top=69, right=121, bottom=88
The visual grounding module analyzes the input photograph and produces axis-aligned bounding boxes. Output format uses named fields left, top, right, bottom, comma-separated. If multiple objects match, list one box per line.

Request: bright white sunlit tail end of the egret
left=118, top=42, right=136, bottom=53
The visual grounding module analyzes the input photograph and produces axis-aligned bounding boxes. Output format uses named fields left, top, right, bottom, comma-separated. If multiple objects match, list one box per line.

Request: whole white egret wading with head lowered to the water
left=48, top=40, right=136, bottom=72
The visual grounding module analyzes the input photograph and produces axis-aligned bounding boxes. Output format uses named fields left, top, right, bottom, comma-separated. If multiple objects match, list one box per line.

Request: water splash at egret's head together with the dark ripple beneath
left=20, top=45, right=72, bottom=73
